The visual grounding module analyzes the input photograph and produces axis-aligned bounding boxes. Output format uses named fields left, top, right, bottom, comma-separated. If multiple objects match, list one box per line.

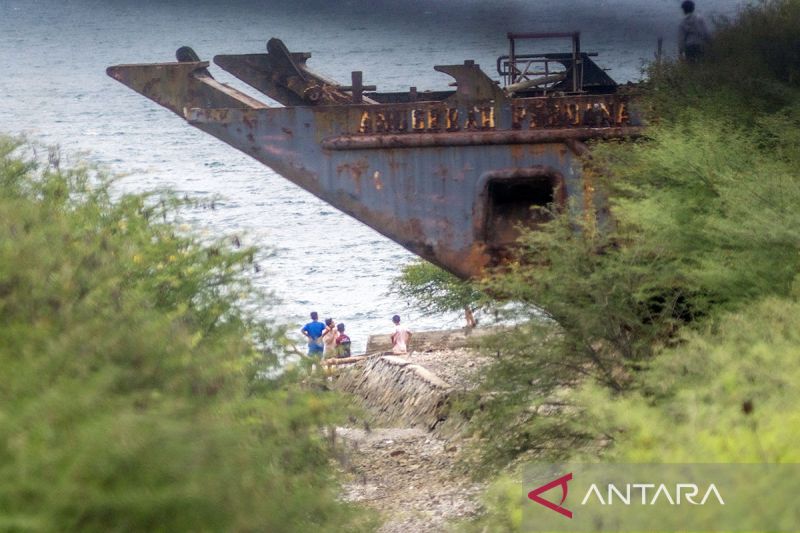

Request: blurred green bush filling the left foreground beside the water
left=0, top=139, right=368, bottom=531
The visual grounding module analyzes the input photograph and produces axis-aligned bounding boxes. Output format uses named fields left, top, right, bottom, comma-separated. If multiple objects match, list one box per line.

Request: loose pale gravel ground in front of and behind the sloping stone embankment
left=337, top=338, right=494, bottom=533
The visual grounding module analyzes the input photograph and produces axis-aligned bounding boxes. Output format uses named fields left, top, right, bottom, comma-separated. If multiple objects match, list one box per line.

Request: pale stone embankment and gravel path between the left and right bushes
left=328, top=330, right=488, bottom=533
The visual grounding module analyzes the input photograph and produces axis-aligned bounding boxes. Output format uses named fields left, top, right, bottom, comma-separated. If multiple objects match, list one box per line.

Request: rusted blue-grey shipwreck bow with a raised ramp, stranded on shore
left=107, top=33, right=640, bottom=278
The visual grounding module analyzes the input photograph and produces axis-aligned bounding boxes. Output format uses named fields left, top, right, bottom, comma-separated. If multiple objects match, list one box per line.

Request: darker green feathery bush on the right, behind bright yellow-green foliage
left=462, top=0, right=800, bottom=474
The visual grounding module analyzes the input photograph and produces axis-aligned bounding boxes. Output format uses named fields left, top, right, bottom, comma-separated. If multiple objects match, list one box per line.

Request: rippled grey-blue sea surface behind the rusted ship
left=0, top=0, right=741, bottom=350
